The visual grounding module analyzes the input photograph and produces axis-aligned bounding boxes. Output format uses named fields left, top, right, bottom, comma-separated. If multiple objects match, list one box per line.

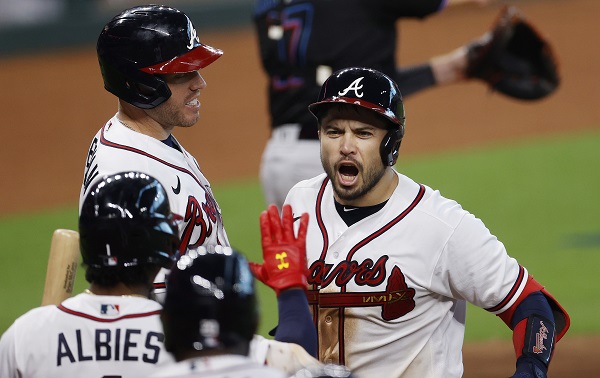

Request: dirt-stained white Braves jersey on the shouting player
left=286, top=173, right=527, bottom=378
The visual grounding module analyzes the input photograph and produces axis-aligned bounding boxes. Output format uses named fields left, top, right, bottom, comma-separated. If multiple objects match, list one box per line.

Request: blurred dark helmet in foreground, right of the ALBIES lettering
left=162, top=246, right=259, bottom=353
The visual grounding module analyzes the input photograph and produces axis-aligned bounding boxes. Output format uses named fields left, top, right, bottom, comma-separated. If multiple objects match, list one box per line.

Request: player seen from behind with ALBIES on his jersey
left=0, top=172, right=179, bottom=378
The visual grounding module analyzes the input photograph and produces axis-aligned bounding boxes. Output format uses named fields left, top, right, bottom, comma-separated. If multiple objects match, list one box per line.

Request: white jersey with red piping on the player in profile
left=79, top=115, right=229, bottom=300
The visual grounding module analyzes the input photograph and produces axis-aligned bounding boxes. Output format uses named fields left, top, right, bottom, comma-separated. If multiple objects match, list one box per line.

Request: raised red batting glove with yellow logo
left=250, top=205, right=308, bottom=296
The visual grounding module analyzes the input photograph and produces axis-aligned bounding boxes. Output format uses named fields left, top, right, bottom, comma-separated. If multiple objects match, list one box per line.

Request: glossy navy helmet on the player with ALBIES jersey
left=79, top=172, right=179, bottom=268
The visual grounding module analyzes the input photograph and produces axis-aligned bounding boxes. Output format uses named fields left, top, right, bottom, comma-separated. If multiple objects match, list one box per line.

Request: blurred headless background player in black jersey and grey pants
left=254, top=0, right=496, bottom=208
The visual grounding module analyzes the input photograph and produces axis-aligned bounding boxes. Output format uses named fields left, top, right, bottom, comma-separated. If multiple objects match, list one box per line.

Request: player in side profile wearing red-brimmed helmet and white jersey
left=79, top=5, right=316, bottom=354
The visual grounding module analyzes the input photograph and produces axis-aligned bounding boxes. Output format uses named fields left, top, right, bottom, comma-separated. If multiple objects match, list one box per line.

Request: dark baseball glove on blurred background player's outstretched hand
left=466, top=6, right=560, bottom=100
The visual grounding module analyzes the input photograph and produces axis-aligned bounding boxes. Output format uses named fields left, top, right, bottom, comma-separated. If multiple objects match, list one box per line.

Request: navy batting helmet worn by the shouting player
left=308, top=67, right=405, bottom=165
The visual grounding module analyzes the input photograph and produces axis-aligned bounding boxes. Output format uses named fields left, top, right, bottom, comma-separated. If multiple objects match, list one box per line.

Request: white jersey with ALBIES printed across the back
left=0, top=294, right=174, bottom=378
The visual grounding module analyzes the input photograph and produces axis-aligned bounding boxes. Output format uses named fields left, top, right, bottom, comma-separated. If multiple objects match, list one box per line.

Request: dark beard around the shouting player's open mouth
left=321, top=156, right=386, bottom=201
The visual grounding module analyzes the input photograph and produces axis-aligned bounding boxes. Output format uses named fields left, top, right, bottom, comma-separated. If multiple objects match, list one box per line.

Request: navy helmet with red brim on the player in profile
left=96, top=5, right=223, bottom=109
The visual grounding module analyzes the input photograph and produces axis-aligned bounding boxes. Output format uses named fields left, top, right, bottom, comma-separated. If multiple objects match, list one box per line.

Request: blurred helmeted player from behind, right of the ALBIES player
left=153, top=246, right=286, bottom=378
